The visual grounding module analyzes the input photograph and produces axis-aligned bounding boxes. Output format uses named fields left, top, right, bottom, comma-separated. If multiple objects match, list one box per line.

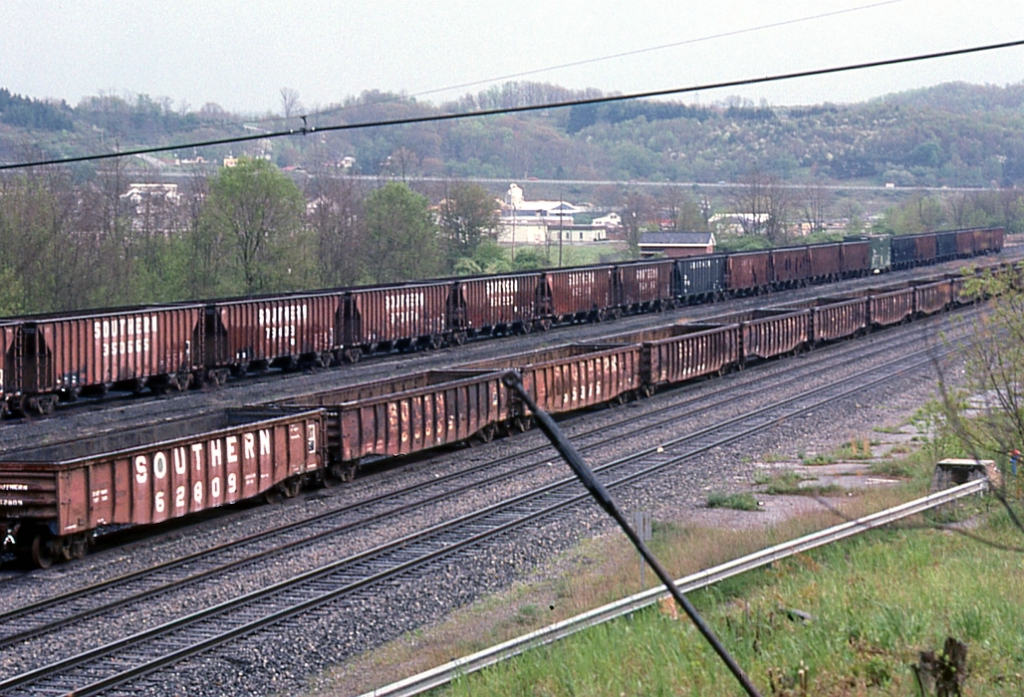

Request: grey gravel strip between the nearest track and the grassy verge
left=110, top=317, right=966, bottom=695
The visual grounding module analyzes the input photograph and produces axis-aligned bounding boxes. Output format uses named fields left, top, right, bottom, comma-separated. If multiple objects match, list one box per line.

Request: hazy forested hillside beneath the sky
left=6, top=83, right=1024, bottom=186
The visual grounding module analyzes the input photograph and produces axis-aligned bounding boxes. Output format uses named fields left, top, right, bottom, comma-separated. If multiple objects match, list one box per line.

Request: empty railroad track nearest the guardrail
left=0, top=311, right=974, bottom=694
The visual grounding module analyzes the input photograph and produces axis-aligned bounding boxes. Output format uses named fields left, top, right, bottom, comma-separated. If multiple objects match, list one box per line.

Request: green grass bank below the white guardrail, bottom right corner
left=445, top=505, right=1024, bottom=697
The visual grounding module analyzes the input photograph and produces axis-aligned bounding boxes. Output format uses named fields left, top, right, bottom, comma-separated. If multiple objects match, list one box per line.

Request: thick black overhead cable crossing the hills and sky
left=0, top=39, right=1024, bottom=171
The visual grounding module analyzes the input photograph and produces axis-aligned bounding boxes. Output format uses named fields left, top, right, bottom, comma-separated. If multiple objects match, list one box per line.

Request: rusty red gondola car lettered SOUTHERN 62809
left=0, top=409, right=324, bottom=567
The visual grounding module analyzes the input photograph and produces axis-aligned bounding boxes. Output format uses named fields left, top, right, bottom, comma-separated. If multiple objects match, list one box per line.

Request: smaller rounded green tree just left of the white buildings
left=364, top=182, right=440, bottom=284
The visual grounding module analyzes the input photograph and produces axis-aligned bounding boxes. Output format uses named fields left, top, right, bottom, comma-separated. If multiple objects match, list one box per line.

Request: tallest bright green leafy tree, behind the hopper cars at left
left=203, top=158, right=306, bottom=294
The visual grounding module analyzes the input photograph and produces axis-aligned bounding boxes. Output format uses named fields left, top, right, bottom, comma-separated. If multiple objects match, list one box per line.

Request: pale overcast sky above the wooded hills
left=0, top=0, right=1024, bottom=114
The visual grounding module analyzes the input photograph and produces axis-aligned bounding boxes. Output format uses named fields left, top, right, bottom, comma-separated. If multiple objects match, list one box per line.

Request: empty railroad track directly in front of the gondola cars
left=0, top=315, right=950, bottom=650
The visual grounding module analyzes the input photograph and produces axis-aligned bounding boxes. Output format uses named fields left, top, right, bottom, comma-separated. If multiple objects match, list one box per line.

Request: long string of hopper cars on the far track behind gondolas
left=0, top=228, right=1004, bottom=413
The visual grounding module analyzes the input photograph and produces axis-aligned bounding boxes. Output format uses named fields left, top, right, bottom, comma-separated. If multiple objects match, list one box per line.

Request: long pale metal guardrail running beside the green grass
left=360, top=479, right=988, bottom=697
